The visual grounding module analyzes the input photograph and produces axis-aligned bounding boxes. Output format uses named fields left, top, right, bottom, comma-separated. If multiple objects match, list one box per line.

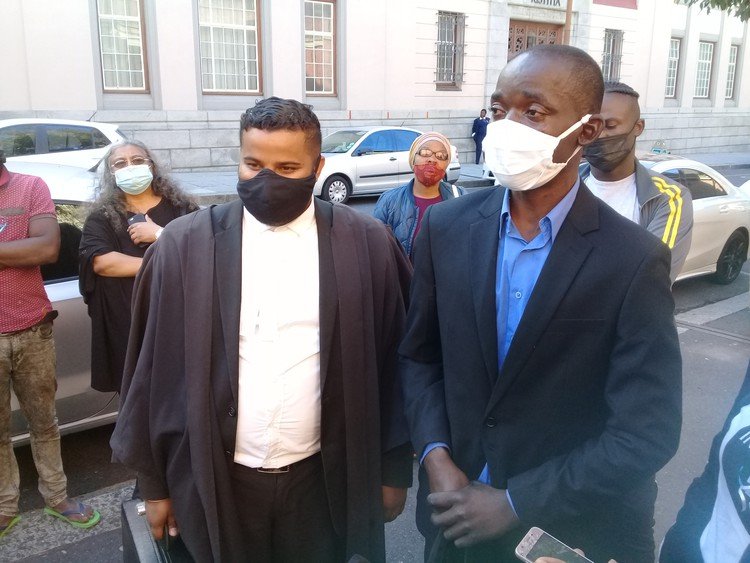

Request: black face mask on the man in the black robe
left=237, top=165, right=317, bottom=227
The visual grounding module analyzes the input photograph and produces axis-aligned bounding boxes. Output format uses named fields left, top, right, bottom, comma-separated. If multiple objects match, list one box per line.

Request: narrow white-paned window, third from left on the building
left=305, top=0, right=336, bottom=95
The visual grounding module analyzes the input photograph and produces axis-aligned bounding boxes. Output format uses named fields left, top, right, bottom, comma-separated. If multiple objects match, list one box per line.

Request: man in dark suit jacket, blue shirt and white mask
left=399, top=46, right=681, bottom=562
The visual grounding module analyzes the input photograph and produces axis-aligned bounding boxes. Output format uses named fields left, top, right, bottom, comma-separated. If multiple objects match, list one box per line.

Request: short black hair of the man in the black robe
left=240, top=96, right=322, bottom=151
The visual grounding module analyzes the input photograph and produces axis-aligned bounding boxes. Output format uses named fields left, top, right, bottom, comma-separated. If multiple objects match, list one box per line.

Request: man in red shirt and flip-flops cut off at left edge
left=0, top=151, right=101, bottom=538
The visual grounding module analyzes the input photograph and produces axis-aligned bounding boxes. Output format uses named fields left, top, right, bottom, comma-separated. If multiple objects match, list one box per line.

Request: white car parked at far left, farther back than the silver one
left=0, top=118, right=126, bottom=168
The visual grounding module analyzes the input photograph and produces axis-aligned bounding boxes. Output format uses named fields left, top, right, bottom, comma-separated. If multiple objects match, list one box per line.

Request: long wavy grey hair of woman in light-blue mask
left=90, top=140, right=197, bottom=231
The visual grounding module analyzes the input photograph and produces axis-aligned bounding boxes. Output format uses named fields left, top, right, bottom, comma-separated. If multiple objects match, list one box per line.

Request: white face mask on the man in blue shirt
left=483, top=114, right=591, bottom=192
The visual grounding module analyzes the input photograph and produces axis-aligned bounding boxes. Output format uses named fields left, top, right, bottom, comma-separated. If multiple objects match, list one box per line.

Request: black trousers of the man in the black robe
left=230, top=454, right=345, bottom=563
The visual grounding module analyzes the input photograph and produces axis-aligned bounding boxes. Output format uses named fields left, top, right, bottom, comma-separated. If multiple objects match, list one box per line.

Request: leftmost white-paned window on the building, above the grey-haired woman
left=96, top=0, right=148, bottom=92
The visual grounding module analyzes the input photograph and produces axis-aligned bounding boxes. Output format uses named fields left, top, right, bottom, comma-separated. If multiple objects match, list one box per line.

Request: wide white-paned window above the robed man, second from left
left=198, top=0, right=260, bottom=93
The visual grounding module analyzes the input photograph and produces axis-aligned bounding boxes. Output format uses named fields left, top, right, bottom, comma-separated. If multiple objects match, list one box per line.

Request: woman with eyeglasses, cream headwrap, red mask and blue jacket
left=373, top=131, right=464, bottom=260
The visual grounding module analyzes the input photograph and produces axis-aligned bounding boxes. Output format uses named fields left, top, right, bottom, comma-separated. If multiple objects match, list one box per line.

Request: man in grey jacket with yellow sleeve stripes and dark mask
left=580, top=82, right=693, bottom=282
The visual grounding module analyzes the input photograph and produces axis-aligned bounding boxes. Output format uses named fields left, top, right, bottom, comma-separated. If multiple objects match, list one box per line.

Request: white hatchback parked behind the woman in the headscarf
left=314, top=126, right=461, bottom=203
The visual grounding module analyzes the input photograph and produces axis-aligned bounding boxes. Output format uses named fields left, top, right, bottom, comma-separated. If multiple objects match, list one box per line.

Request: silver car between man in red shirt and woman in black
left=6, top=161, right=119, bottom=445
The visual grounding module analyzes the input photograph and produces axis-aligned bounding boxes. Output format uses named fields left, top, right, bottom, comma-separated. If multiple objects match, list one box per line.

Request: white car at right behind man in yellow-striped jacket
left=638, top=153, right=750, bottom=284
